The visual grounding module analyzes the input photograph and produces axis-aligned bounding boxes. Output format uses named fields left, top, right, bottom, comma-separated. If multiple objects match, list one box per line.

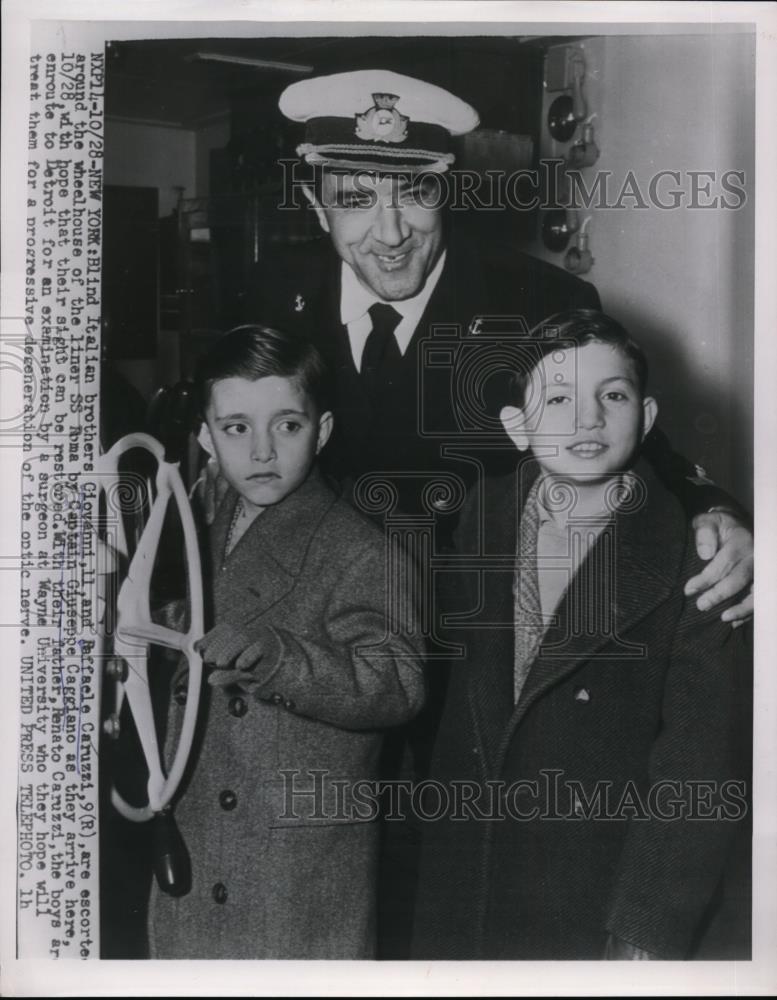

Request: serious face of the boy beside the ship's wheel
left=203, top=375, right=332, bottom=507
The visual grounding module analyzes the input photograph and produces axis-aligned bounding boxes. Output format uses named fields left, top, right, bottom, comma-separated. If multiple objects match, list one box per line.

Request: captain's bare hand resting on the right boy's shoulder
left=685, top=510, right=753, bottom=628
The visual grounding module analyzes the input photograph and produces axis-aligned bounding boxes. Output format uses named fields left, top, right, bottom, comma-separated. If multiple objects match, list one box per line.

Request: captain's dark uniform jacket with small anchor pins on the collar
left=245, top=238, right=599, bottom=513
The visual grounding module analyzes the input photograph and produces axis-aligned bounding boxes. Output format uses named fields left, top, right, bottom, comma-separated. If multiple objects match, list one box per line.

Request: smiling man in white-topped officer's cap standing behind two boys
left=236, top=70, right=752, bottom=958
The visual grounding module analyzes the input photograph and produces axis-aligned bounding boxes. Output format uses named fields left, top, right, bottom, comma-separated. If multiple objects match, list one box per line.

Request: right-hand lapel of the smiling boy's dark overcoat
left=508, top=462, right=686, bottom=733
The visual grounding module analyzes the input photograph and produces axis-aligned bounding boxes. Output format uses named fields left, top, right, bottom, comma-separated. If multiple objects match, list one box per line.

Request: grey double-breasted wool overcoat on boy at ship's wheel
left=150, top=473, right=424, bottom=959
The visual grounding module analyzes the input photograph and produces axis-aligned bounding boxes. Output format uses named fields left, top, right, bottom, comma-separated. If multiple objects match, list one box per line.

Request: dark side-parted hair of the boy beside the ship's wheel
left=194, top=324, right=331, bottom=418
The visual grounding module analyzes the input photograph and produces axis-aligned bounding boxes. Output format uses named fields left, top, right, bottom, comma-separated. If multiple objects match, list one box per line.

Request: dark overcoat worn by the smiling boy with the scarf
left=413, top=462, right=749, bottom=959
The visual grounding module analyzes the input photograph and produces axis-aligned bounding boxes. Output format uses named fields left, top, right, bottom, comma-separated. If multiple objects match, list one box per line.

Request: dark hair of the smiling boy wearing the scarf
left=510, top=309, right=648, bottom=406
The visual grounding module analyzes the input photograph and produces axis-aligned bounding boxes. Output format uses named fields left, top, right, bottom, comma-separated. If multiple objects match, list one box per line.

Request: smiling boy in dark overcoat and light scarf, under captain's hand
left=413, top=310, right=749, bottom=959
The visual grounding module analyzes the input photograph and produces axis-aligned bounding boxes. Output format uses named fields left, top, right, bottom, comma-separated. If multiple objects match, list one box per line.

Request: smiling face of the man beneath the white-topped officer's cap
left=314, top=170, right=443, bottom=302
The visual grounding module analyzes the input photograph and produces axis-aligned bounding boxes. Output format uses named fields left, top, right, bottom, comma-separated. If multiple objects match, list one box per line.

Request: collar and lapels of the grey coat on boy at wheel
left=211, top=469, right=337, bottom=624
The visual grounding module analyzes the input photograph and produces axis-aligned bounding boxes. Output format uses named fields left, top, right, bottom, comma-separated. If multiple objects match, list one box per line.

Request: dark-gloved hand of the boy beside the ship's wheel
left=194, top=622, right=280, bottom=694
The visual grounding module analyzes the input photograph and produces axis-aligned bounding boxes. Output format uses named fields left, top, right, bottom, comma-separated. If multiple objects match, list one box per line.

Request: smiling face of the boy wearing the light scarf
left=501, top=341, right=657, bottom=482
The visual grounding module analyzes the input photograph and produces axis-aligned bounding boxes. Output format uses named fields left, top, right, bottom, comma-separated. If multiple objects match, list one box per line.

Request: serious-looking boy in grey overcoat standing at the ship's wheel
left=150, top=327, right=424, bottom=959
